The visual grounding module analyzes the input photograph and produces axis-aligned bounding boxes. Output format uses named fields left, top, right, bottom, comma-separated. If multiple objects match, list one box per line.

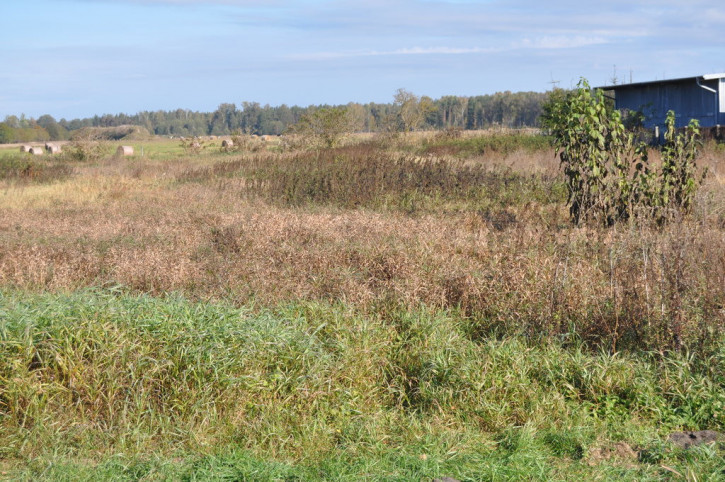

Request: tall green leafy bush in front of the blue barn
left=547, top=80, right=704, bottom=226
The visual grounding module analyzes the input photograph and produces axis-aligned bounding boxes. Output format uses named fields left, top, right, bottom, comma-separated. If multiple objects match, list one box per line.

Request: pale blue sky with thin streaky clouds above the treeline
left=0, top=0, right=725, bottom=120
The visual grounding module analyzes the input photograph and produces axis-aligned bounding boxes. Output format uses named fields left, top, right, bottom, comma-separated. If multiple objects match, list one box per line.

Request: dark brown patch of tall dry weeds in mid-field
left=178, top=144, right=564, bottom=213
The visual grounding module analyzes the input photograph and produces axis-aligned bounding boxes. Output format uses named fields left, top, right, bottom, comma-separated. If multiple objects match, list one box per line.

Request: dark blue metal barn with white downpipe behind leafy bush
left=598, top=73, right=725, bottom=129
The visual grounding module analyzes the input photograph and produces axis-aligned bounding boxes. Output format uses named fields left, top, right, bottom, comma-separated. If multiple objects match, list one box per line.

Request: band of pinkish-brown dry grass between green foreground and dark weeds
left=0, top=137, right=725, bottom=349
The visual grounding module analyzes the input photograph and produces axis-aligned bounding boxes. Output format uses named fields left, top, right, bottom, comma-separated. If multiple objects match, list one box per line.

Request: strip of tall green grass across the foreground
left=0, top=289, right=725, bottom=480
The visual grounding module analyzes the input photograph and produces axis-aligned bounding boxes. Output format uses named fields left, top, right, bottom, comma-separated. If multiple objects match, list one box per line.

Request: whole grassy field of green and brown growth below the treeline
left=0, top=133, right=725, bottom=480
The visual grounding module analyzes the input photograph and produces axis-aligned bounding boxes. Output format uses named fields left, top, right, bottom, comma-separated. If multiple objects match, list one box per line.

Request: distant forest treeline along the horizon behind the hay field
left=0, top=92, right=550, bottom=143
